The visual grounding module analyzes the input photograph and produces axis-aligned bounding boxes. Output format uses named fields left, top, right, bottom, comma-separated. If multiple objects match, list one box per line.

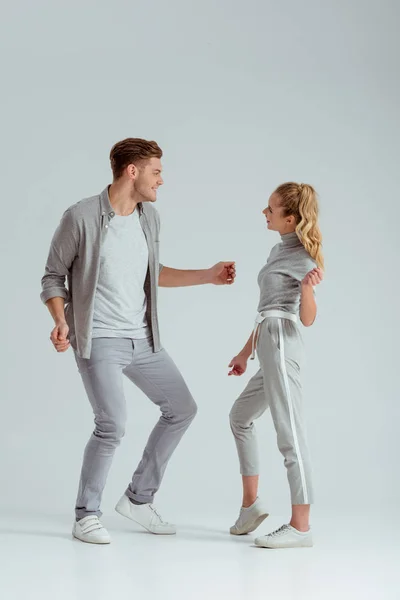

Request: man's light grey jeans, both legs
left=75, top=338, right=197, bottom=519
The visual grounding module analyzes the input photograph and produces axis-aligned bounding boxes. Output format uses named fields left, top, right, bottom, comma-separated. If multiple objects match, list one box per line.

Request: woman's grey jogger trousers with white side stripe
left=230, top=317, right=313, bottom=504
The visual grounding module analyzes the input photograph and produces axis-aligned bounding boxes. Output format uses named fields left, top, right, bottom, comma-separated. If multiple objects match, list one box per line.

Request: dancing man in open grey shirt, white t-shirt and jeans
left=41, top=138, right=235, bottom=544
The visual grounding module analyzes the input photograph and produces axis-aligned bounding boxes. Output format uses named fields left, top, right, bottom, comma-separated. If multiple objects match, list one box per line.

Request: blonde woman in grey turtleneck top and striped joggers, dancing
left=229, top=183, right=323, bottom=548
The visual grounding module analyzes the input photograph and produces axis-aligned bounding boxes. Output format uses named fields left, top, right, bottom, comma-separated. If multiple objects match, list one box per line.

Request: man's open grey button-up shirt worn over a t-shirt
left=40, top=187, right=162, bottom=358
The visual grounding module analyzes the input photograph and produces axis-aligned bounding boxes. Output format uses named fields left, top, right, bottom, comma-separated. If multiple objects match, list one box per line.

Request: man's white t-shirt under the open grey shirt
left=93, top=209, right=150, bottom=339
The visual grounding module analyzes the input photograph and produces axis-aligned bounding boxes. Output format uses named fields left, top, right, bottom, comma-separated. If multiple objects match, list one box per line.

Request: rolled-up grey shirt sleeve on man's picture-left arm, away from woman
left=40, top=209, right=79, bottom=303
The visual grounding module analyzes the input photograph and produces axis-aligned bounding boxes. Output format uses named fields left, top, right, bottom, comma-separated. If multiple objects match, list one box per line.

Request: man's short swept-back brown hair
left=110, top=138, right=162, bottom=179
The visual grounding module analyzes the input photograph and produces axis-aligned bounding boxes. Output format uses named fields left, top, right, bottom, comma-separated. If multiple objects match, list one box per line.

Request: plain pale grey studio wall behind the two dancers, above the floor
left=0, top=0, right=400, bottom=525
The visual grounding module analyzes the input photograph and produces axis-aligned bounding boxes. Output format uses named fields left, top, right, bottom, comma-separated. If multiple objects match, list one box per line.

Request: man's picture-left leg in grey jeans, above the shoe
left=76, top=338, right=133, bottom=519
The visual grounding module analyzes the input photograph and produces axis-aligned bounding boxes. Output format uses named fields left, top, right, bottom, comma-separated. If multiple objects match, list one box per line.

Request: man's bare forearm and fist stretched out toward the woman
left=158, top=261, right=236, bottom=287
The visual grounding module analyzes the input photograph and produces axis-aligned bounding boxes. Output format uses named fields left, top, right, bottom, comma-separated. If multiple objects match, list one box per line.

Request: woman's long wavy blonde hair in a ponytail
left=275, top=182, right=324, bottom=269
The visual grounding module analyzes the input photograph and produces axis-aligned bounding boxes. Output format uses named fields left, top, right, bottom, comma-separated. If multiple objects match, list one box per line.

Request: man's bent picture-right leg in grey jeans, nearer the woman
left=124, top=340, right=197, bottom=503
